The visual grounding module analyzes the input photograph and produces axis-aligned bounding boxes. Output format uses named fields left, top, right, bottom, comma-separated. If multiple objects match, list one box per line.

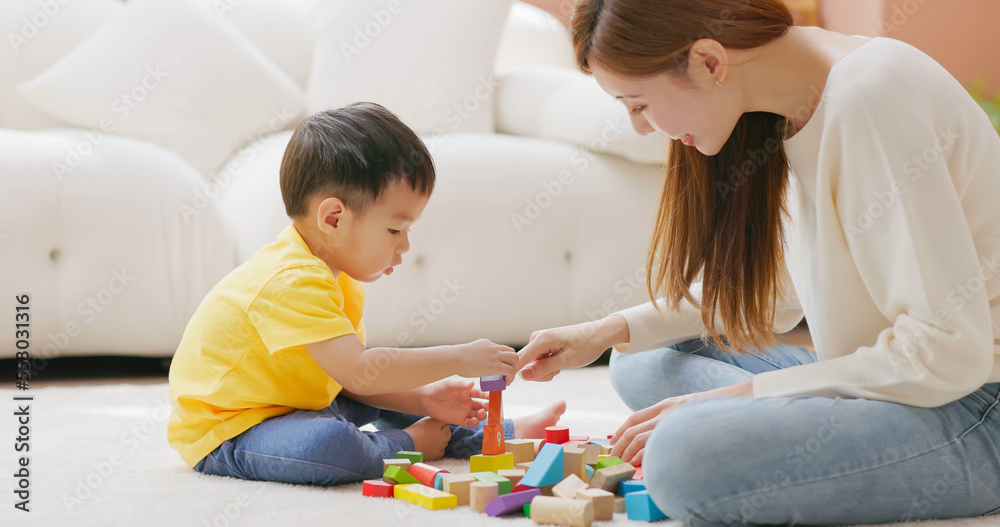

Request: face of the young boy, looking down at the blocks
left=314, top=180, right=430, bottom=282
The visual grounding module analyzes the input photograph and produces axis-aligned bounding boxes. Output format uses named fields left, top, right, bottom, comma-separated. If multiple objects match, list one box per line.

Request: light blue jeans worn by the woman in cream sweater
left=611, top=339, right=1000, bottom=527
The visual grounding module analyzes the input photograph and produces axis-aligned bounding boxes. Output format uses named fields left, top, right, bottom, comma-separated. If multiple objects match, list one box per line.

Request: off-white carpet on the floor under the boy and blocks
left=0, top=367, right=1000, bottom=527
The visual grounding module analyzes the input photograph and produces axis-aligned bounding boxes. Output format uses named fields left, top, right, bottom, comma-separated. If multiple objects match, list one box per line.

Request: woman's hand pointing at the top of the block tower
left=518, top=315, right=628, bottom=381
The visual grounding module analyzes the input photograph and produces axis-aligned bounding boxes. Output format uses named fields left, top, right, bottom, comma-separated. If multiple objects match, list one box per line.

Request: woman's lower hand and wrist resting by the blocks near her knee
left=611, top=379, right=753, bottom=467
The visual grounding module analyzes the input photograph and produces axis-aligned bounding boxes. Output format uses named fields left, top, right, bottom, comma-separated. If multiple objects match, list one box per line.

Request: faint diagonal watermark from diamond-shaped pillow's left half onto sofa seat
left=52, top=64, right=170, bottom=183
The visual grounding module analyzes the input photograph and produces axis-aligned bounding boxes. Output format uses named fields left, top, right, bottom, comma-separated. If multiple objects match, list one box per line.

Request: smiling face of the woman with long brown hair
left=591, top=58, right=741, bottom=156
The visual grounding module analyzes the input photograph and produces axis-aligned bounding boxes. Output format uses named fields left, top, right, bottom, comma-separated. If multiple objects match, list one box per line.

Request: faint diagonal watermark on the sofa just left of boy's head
left=177, top=106, right=296, bottom=224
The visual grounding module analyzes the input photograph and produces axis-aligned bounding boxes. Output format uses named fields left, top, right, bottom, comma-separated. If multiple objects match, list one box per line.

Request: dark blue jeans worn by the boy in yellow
left=194, top=395, right=514, bottom=485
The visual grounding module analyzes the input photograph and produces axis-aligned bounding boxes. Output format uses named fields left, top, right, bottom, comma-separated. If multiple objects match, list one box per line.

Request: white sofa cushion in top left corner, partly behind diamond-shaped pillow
left=0, top=0, right=122, bottom=130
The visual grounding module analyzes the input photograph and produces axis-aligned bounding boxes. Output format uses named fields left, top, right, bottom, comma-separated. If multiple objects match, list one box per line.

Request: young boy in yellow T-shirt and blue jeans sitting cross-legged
left=167, top=103, right=565, bottom=485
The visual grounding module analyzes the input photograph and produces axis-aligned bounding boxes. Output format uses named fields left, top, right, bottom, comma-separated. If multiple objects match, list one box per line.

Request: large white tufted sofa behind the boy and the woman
left=0, top=0, right=665, bottom=358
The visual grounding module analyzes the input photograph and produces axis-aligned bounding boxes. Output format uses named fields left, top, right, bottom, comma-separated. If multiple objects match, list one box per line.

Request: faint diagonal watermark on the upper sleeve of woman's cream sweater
left=844, top=127, right=958, bottom=241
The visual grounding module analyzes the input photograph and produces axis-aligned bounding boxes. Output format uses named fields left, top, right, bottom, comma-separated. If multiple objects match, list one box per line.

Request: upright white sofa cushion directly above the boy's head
left=306, top=0, right=512, bottom=134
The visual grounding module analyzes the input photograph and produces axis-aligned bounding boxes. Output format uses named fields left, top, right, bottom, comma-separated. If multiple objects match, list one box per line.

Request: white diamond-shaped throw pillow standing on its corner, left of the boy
left=18, top=0, right=304, bottom=175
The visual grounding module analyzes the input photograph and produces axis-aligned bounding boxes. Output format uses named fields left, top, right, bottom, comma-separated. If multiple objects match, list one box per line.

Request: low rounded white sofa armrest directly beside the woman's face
left=496, top=67, right=667, bottom=165
